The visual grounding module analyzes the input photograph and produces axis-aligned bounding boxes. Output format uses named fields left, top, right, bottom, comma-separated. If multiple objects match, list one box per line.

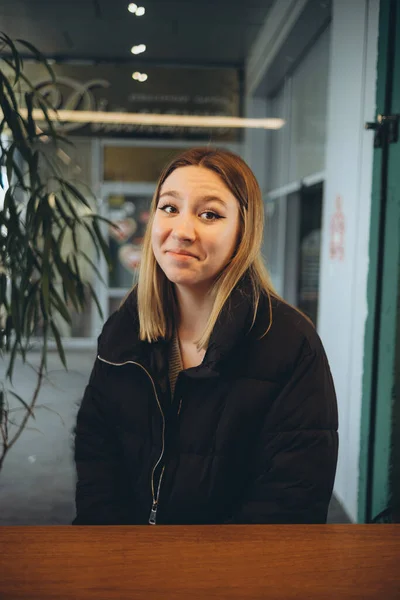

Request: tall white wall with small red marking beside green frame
left=318, top=0, right=379, bottom=520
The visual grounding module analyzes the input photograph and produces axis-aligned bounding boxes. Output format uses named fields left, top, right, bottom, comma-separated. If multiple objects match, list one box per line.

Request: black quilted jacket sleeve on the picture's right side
left=229, top=343, right=338, bottom=523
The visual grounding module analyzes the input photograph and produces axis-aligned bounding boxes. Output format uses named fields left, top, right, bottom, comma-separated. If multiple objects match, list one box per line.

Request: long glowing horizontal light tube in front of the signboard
left=14, top=109, right=286, bottom=129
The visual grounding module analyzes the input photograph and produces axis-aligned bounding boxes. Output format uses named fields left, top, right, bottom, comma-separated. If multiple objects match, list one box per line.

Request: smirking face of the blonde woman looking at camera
left=151, top=166, right=239, bottom=291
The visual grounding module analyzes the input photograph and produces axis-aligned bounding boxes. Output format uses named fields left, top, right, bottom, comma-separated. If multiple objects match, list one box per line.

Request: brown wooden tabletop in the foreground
left=0, top=525, right=400, bottom=600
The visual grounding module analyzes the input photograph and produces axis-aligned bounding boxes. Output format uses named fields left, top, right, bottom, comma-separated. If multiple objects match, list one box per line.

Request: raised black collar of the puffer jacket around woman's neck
left=98, top=278, right=262, bottom=378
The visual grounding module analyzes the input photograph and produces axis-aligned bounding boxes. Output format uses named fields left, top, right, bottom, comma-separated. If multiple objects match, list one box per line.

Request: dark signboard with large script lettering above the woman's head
left=19, top=63, right=241, bottom=142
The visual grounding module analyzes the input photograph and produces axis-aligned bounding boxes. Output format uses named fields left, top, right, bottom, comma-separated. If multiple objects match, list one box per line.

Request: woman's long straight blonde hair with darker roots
left=137, top=148, right=279, bottom=349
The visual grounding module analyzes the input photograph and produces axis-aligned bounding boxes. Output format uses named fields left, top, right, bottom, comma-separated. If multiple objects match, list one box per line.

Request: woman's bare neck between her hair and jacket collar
left=175, top=285, right=213, bottom=343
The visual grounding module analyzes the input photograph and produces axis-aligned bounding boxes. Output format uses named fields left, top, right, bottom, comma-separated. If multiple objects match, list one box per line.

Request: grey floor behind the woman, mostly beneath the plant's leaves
left=0, top=350, right=349, bottom=525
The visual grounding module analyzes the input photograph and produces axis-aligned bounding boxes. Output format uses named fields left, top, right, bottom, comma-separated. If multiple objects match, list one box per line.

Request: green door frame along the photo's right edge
left=358, top=0, right=400, bottom=523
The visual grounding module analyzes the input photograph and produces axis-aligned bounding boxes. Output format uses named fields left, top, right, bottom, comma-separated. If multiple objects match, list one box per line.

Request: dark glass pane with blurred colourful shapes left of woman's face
left=108, top=195, right=151, bottom=288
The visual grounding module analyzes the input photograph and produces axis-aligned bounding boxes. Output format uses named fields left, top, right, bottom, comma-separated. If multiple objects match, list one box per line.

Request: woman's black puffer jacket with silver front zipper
left=74, top=288, right=338, bottom=525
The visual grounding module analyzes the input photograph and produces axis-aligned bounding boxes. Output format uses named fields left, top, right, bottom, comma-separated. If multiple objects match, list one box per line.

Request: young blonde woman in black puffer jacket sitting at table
left=74, top=148, right=338, bottom=525
